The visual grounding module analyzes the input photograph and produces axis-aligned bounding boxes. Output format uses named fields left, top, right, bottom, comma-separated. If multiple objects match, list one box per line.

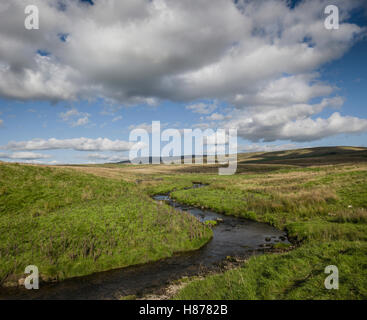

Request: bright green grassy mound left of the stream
left=0, top=163, right=212, bottom=285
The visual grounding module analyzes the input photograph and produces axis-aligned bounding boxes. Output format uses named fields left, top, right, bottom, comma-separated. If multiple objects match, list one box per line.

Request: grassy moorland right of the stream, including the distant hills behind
left=72, top=147, right=367, bottom=299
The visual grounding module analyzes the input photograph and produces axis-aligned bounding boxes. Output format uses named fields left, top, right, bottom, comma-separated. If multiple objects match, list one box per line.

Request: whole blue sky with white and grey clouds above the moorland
left=0, top=0, right=367, bottom=164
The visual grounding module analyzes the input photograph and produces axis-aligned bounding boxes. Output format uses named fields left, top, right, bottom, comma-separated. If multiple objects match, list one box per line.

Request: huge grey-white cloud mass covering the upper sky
left=0, top=0, right=366, bottom=142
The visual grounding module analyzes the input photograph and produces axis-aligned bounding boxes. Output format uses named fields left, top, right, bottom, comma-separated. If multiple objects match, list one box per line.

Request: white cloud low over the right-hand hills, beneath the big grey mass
left=222, top=97, right=367, bottom=142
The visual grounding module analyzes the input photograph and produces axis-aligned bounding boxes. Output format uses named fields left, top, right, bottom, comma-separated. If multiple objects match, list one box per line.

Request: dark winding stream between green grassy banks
left=0, top=185, right=288, bottom=299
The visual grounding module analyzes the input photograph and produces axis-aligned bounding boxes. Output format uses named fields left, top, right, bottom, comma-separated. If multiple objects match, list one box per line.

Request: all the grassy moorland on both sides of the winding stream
left=0, top=147, right=367, bottom=299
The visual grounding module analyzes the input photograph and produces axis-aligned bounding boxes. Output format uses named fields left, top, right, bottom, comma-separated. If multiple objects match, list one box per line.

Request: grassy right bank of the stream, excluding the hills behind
left=173, top=163, right=367, bottom=299
